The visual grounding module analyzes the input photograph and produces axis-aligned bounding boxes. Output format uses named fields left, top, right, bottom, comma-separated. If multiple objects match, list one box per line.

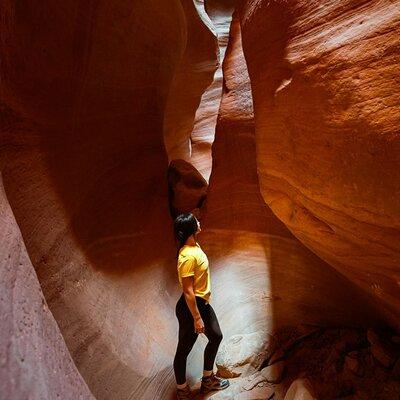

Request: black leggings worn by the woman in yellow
left=174, top=293, right=222, bottom=385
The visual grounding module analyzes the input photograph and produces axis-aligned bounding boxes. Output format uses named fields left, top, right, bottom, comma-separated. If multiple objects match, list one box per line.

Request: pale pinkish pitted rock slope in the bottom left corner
left=0, top=174, right=94, bottom=400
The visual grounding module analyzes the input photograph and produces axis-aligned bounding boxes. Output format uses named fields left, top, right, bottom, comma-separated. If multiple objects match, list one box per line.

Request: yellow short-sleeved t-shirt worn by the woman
left=178, top=243, right=211, bottom=302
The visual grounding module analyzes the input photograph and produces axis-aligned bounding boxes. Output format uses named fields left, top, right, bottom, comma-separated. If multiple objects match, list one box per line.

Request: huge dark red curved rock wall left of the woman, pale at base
left=0, top=0, right=185, bottom=399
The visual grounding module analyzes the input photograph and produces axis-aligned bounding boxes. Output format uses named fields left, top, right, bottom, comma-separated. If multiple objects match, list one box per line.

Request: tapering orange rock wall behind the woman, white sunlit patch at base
left=199, top=10, right=380, bottom=350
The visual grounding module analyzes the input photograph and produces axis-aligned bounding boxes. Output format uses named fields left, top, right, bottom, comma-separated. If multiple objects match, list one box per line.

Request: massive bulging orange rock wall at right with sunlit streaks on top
left=240, top=0, right=400, bottom=328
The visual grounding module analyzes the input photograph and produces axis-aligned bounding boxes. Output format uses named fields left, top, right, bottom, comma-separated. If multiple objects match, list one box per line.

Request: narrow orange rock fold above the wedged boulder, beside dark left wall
left=164, top=0, right=219, bottom=168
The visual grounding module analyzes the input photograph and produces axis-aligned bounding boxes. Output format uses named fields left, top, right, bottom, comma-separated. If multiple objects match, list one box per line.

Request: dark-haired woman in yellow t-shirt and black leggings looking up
left=174, top=213, right=229, bottom=400
